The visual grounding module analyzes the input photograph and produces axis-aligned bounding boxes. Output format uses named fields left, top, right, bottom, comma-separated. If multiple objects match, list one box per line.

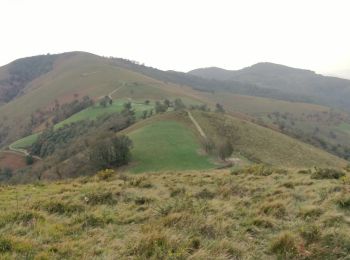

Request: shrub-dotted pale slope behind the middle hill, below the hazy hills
left=196, top=91, right=350, bottom=158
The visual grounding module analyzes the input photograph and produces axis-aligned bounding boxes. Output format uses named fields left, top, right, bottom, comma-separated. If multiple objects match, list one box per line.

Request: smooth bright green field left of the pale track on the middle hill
left=129, top=121, right=214, bottom=172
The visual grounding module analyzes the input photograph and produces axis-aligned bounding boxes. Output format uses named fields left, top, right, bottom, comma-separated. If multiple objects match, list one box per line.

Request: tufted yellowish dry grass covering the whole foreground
left=0, top=166, right=350, bottom=259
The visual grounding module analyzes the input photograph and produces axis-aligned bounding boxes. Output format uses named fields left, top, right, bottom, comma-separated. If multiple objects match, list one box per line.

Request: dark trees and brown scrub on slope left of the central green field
left=3, top=113, right=135, bottom=183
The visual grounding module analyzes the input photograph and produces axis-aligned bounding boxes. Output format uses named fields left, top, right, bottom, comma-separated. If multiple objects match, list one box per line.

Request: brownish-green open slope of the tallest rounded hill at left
left=0, top=52, right=202, bottom=146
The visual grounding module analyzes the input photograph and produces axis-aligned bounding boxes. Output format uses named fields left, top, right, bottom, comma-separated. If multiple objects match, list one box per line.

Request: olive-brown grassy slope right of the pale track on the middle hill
left=193, top=112, right=346, bottom=167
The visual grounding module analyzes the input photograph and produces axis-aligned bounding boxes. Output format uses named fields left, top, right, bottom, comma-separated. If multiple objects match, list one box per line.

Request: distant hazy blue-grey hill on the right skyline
left=189, top=63, right=350, bottom=111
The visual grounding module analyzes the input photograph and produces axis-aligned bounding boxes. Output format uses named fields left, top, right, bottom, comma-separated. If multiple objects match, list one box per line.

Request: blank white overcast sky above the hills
left=0, top=0, right=350, bottom=78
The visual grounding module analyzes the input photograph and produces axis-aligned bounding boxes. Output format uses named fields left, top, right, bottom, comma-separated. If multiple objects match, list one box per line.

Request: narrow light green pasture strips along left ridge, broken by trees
left=11, top=100, right=154, bottom=149
